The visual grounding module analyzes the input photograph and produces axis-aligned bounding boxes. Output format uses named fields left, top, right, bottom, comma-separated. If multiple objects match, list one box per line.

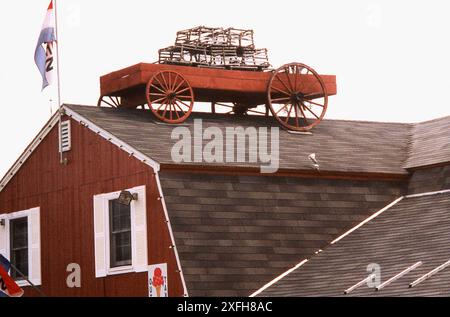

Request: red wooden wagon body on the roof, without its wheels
left=100, top=63, right=336, bottom=108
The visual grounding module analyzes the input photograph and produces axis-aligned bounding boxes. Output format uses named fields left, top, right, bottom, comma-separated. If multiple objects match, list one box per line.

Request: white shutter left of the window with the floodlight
left=94, top=195, right=107, bottom=277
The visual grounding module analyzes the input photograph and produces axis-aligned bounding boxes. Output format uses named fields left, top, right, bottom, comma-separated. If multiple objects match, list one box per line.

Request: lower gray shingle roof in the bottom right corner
left=260, top=192, right=450, bottom=296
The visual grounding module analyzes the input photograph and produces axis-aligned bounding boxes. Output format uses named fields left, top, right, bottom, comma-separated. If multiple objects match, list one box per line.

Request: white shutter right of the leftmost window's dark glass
left=28, top=208, right=41, bottom=285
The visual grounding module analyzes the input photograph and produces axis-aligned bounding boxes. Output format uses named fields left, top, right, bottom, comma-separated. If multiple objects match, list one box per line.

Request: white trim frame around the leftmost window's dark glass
left=0, top=207, right=42, bottom=287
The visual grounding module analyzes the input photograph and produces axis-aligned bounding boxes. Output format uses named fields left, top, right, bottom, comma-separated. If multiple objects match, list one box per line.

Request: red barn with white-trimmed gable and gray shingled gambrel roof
left=0, top=105, right=443, bottom=296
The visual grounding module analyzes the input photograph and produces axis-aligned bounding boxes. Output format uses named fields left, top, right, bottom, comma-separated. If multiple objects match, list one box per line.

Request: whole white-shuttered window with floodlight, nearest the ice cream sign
left=93, top=186, right=148, bottom=277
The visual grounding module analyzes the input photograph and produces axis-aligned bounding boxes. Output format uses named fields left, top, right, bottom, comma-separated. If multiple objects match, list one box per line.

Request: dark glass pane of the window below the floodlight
left=109, top=199, right=131, bottom=267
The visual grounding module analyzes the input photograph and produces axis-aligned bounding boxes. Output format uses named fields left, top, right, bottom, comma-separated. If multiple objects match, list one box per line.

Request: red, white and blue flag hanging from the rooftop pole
left=34, top=0, right=56, bottom=90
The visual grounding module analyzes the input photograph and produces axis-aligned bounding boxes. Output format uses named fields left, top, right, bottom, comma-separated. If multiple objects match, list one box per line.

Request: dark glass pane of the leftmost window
left=9, top=217, right=28, bottom=280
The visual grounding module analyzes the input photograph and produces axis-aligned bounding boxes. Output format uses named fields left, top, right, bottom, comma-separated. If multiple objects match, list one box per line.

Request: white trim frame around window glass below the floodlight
left=94, top=186, right=148, bottom=276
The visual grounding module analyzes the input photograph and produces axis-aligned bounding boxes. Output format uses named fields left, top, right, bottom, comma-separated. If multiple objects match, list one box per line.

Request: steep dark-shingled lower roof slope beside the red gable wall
left=160, top=172, right=402, bottom=296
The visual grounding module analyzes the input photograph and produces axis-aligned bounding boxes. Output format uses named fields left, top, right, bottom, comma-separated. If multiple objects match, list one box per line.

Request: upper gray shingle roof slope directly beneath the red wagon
left=67, top=105, right=410, bottom=174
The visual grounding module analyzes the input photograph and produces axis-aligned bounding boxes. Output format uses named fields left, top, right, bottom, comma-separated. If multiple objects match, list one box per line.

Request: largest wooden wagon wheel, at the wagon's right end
left=267, top=63, right=328, bottom=131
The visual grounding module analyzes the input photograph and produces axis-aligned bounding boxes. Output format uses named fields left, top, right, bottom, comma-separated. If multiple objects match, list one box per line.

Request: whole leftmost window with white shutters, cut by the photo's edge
left=0, top=207, right=41, bottom=286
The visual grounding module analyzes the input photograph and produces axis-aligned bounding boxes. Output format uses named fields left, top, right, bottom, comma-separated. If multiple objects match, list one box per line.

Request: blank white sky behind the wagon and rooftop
left=0, top=0, right=450, bottom=177
